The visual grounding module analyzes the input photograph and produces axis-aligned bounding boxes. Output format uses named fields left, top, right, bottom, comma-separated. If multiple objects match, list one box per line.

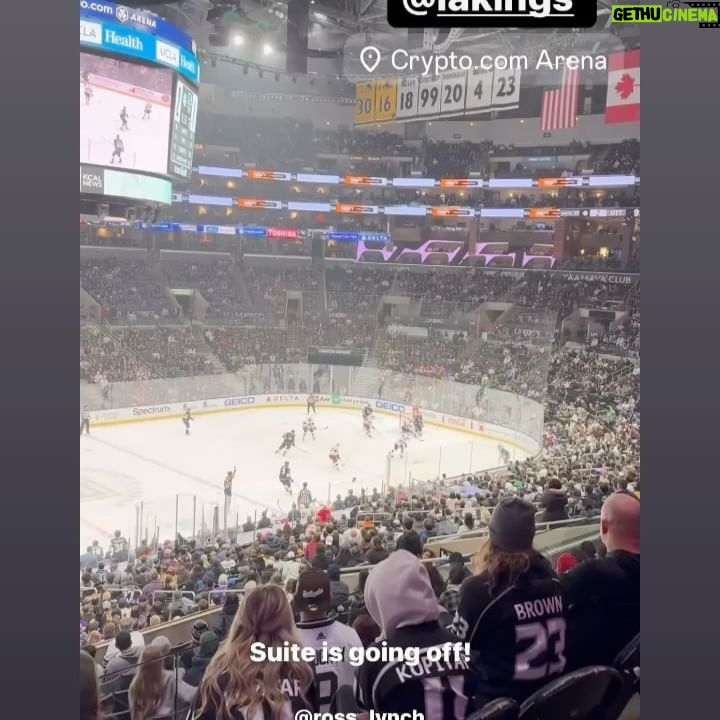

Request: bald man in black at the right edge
left=560, top=492, right=640, bottom=670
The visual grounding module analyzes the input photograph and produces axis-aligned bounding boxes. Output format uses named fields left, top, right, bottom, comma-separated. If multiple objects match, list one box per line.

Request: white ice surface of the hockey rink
left=80, top=408, right=526, bottom=550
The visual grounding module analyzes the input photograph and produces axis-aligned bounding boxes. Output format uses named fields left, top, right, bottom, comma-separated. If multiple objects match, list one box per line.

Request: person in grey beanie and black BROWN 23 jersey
left=452, top=497, right=565, bottom=702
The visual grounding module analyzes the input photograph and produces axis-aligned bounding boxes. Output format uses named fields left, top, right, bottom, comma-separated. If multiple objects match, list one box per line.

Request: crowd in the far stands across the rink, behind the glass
left=80, top=261, right=640, bottom=386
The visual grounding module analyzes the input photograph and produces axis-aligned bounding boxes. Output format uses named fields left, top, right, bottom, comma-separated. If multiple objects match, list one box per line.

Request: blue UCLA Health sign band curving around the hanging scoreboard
left=80, top=18, right=200, bottom=85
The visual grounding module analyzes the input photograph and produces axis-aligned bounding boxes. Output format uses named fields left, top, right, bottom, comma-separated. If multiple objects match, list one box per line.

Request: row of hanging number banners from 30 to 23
left=354, top=68, right=522, bottom=125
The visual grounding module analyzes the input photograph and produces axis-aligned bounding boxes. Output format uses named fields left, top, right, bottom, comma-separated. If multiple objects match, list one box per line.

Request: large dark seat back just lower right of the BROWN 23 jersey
left=519, top=665, right=622, bottom=720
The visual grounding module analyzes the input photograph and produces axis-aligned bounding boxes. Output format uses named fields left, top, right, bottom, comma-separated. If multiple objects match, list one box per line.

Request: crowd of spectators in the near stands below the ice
left=80, top=458, right=640, bottom=718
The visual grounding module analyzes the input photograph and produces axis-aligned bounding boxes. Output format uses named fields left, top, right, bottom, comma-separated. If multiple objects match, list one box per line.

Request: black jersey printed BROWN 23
left=452, top=557, right=566, bottom=702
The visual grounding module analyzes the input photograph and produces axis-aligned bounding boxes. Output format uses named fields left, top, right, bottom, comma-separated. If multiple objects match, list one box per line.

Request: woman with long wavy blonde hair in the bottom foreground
left=193, top=585, right=318, bottom=720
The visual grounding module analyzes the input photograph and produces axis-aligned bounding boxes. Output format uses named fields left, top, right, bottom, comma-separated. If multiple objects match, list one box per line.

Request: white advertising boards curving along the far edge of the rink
left=90, top=393, right=540, bottom=454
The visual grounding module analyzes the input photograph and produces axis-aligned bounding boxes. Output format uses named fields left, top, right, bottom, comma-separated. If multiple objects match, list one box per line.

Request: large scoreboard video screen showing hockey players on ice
left=80, top=52, right=173, bottom=175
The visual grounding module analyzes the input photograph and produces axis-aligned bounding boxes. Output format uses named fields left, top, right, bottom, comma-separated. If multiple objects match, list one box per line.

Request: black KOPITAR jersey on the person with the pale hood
left=355, top=622, right=476, bottom=720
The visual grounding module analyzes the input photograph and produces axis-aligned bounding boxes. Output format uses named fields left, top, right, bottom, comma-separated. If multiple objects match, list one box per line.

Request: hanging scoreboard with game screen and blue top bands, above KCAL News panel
left=80, top=0, right=200, bottom=186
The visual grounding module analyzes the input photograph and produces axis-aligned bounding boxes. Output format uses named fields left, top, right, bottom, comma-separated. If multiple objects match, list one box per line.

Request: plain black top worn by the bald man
left=560, top=550, right=640, bottom=670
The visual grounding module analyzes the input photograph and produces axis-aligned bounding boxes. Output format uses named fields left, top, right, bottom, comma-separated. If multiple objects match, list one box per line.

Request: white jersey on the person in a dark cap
left=297, top=618, right=363, bottom=713
